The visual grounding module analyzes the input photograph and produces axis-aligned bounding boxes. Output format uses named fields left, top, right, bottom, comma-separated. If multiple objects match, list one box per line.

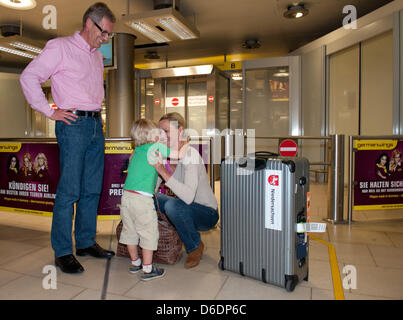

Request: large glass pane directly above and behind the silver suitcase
left=243, top=57, right=301, bottom=152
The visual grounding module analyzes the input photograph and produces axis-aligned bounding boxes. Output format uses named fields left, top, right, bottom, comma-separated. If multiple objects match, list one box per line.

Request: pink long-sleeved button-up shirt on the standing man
left=20, top=31, right=104, bottom=117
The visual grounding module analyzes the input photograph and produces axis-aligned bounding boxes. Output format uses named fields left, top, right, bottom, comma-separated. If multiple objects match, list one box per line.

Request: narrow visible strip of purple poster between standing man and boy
left=98, top=142, right=133, bottom=219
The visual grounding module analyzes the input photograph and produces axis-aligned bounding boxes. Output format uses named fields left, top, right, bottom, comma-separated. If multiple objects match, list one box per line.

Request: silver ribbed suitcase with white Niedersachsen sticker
left=219, top=152, right=309, bottom=292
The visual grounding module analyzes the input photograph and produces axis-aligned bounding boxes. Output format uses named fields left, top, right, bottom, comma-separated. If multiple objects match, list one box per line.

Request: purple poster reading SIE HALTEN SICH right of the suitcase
left=354, top=140, right=403, bottom=210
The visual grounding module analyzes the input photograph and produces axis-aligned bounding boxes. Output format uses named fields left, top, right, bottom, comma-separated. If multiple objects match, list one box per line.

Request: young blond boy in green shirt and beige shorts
left=119, top=119, right=183, bottom=281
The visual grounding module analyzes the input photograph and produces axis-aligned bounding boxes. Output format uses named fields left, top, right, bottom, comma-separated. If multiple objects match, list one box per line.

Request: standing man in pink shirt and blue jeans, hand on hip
left=20, top=2, right=116, bottom=273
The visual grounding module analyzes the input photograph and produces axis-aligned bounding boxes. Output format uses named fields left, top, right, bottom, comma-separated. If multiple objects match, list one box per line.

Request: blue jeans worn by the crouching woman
left=156, top=193, right=218, bottom=253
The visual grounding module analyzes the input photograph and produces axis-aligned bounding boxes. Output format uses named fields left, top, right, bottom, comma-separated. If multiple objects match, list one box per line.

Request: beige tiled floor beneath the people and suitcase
left=0, top=184, right=403, bottom=300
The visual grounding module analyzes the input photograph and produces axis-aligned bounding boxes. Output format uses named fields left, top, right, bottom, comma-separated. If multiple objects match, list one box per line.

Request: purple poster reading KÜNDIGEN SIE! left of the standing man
left=0, top=142, right=60, bottom=215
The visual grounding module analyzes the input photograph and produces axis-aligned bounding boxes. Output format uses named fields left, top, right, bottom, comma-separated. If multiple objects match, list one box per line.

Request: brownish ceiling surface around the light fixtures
left=0, top=0, right=391, bottom=67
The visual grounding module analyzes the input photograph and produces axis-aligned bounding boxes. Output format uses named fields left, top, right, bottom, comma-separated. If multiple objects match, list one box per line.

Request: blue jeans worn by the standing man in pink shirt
left=51, top=116, right=105, bottom=258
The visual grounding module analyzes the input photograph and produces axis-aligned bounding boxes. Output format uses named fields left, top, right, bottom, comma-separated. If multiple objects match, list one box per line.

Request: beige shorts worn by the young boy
left=119, top=190, right=159, bottom=251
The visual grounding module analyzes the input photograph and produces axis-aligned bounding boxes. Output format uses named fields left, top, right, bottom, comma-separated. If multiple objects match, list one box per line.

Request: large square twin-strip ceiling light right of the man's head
left=122, top=8, right=200, bottom=43
